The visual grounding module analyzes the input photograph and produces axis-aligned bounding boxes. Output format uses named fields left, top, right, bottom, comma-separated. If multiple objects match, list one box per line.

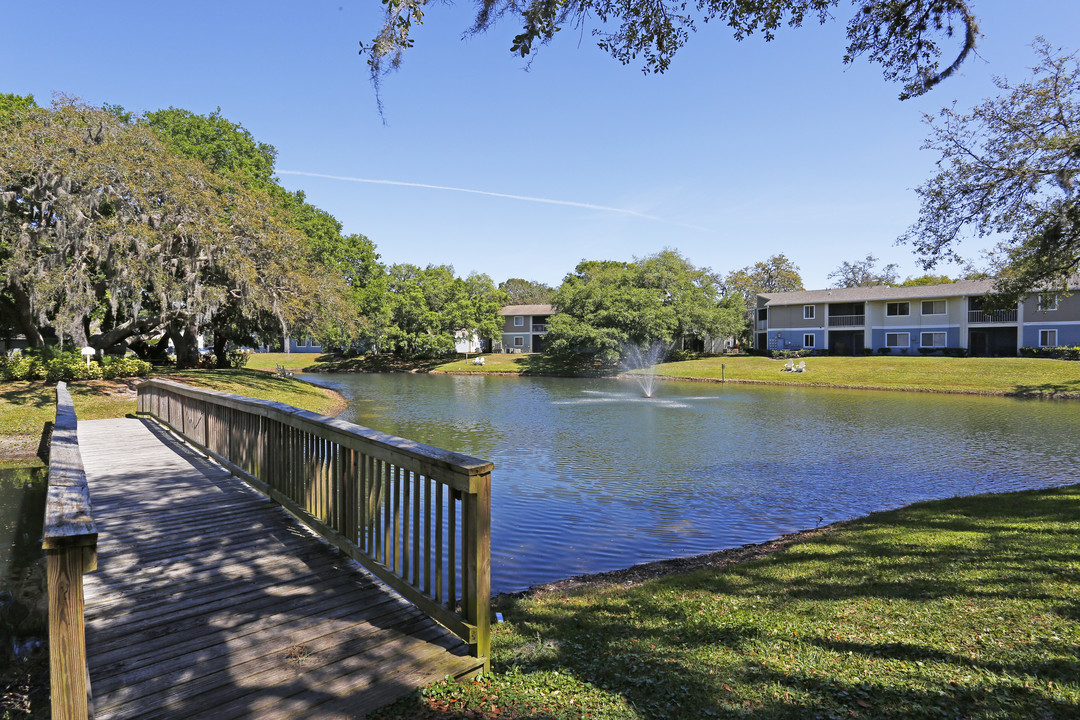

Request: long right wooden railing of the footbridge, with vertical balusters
left=138, top=380, right=494, bottom=663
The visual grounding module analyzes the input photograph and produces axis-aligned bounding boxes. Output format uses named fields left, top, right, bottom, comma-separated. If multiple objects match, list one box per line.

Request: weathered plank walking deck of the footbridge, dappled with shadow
left=79, top=419, right=482, bottom=720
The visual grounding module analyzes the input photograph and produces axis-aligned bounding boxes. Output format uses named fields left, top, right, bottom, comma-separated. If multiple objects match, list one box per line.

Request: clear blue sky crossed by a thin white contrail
left=0, top=0, right=1080, bottom=287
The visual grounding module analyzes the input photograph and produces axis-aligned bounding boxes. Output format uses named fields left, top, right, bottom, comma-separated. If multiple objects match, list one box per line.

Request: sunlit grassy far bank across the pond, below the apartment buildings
left=248, top=353, right=1080, bottom=397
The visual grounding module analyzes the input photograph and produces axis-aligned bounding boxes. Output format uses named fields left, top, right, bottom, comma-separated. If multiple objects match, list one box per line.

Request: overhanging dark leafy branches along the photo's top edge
left=361, top=0, right=978, bottom=99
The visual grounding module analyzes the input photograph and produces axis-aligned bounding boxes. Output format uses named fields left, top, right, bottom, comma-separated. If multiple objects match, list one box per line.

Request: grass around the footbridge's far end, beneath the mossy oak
left=0, top=369, right=343, bottom=466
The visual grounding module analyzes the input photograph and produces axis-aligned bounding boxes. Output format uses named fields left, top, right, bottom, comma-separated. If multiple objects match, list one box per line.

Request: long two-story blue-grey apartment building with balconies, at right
left=754, top=280, right=1080, bottom=355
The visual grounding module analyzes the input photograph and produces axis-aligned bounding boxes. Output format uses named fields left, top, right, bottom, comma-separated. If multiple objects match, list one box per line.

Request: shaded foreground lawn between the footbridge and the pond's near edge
left=378, top=486, right=1080, bottom=720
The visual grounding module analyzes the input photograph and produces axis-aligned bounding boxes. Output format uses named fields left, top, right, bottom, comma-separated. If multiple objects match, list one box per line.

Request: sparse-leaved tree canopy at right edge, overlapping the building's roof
left=901, top=39, right=1080, bottom=303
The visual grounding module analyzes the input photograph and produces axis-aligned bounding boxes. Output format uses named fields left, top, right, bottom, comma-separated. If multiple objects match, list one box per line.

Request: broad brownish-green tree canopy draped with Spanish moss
left=0, top=98, right=358, bottom=363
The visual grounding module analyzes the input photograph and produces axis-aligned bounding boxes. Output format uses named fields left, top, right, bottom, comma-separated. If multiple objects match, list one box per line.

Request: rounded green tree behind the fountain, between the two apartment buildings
left=545, top=249, right=742, bottom=363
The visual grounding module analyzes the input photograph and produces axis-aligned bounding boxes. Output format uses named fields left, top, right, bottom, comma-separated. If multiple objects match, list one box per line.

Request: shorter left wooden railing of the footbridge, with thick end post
left=42, top=382, right=97, bottom=720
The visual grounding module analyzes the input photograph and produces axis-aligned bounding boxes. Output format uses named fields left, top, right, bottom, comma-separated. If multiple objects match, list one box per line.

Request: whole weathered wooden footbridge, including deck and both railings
left=44, top=380, right=491, bottom=720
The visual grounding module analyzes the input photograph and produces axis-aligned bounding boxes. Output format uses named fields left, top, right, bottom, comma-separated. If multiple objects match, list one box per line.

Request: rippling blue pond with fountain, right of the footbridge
left=305, top=373, right=1080, bottom=592
